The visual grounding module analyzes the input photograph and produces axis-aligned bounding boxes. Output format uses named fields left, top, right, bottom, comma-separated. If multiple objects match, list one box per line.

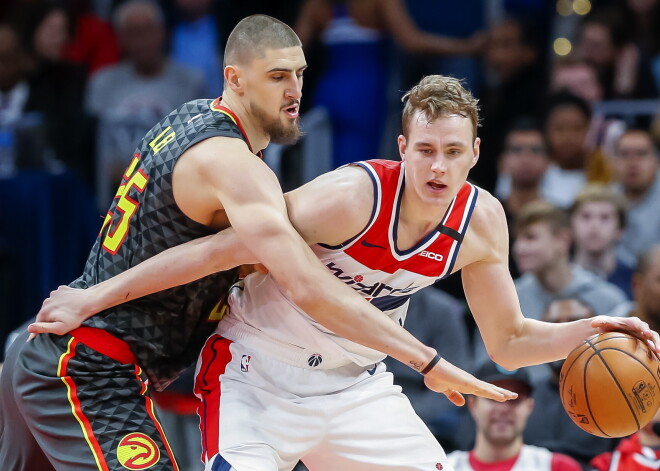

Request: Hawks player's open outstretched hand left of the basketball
left=424, top=358, right=518, bottom=406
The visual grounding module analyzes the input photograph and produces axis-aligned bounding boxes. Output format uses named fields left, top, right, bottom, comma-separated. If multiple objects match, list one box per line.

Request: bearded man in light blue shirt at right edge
left=612, top=129, right=660, bottom=262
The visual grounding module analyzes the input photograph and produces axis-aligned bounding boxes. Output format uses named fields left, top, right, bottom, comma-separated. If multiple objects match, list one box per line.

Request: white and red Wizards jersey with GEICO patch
left=218, top=160, right=478, bottom=368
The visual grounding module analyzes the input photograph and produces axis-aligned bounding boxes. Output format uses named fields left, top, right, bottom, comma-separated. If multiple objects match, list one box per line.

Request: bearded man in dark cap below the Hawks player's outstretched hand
left=447, top=361, right=582, bottom=471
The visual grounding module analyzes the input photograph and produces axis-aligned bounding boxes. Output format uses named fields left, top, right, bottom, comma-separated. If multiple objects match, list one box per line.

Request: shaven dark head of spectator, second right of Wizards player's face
left=546, top=104, right=589, bottom=169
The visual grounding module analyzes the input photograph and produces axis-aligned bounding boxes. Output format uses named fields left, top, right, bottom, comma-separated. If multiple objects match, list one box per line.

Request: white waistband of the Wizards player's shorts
left=217, top=317, right=354, bottom=370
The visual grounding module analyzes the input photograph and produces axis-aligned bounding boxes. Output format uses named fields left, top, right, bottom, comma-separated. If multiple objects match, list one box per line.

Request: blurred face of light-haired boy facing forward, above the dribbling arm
left=571, top=201, right=621, bottom=254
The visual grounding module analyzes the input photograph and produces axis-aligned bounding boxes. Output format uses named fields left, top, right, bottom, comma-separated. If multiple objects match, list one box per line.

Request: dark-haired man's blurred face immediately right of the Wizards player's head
left=502, top=130, right=548, bottom=189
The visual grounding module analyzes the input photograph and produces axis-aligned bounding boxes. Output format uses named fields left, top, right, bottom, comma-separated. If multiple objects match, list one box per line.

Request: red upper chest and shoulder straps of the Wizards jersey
left=343, top=160, right=477, bottom=278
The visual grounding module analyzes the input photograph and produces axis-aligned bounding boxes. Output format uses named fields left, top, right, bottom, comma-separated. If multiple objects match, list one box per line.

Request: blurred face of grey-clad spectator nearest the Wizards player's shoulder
left=513, top=221, right=570, bottom=273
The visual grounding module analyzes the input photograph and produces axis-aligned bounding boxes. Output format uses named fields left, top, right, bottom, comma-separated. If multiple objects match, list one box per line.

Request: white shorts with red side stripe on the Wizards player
left=195, top=335, right=453, bottom=471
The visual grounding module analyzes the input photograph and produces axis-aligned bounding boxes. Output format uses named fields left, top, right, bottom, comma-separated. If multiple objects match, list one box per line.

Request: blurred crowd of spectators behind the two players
left=0, top=0, right=660, bottom=469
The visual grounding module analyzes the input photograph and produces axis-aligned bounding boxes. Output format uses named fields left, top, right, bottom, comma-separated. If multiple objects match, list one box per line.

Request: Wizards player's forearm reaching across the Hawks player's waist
left=88, top=229, right=255, bottom=315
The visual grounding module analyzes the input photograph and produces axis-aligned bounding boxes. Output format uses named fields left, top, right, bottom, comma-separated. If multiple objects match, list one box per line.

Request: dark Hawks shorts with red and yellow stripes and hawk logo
left=0, top=327, right=179, bottom=471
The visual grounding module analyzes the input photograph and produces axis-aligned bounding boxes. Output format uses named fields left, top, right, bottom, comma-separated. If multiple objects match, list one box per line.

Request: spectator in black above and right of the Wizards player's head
left=471, top=18, right=545, bottom=191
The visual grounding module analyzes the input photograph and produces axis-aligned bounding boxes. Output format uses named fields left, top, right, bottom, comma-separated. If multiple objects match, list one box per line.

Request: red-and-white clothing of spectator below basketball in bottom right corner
left=589, top=410, right=660, bottom=471
